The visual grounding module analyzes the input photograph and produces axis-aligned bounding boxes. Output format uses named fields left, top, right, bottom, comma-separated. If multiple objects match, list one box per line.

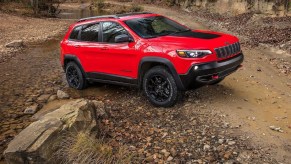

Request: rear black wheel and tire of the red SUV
left=66, top=62, right=87, bottom=90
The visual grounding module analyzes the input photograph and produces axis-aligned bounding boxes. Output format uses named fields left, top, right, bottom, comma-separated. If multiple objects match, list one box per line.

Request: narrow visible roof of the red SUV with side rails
left=78, top=12, right=156, bottom=22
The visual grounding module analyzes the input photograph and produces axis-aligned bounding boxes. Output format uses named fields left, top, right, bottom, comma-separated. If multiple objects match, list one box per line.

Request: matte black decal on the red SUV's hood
left=170, top=31, right=221, bottom=39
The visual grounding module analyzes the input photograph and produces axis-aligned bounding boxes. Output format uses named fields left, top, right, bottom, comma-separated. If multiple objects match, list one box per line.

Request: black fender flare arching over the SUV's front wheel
left=138, top=57, right=185, bottom=90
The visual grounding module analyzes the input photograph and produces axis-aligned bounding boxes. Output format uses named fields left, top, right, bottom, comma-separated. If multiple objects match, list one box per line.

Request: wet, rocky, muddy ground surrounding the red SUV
left=0, top=0, right=291, bottom=163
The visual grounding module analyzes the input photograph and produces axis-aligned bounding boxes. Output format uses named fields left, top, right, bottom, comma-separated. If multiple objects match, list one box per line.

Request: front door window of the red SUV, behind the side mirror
left=102, top=22, right=128, bottom=43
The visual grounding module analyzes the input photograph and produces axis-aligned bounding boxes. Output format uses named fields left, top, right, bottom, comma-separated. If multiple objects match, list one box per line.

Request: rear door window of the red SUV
left=81, top=23, right=99, bottom=42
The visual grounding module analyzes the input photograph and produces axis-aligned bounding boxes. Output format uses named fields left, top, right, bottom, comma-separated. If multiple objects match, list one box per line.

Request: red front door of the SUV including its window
left=96, top=22, right=138, bottom=78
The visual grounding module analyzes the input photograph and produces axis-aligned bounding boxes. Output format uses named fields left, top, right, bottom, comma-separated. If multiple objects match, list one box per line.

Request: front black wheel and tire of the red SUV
left=143, top=66, right=182, bottom=107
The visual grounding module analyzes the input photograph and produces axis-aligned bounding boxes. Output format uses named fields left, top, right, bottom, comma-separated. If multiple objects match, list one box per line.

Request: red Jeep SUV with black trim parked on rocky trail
left=61, top=12, right=244, bottom=107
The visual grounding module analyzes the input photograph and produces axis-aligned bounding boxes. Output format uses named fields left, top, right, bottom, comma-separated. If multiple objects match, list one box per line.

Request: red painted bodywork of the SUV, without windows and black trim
left=61, top=14, right=242, bottom=79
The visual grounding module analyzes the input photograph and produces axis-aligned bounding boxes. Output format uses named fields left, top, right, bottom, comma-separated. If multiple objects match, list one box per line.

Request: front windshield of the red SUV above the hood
left=125, top=16, right=190, bottom=38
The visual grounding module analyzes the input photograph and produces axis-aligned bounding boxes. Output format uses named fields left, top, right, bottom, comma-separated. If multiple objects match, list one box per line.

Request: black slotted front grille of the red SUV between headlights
left=214, top=42, right=241, bottom=58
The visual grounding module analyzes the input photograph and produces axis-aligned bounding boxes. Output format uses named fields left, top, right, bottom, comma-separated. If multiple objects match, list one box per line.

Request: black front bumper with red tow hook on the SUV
left=179, top=53, right=244, bottom=89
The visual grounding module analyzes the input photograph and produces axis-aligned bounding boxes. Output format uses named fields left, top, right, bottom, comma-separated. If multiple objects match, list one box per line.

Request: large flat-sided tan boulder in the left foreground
left=4, top=99, right=105, bottom=164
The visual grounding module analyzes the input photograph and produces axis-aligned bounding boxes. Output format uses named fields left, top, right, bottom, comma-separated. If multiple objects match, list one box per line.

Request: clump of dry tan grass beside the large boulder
left=53, top=132, right=133, bottom=164
